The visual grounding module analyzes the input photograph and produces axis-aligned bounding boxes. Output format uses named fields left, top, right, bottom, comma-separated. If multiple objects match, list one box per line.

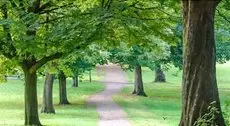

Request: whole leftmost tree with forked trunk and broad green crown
left=0, top=0, right=101, bottom=125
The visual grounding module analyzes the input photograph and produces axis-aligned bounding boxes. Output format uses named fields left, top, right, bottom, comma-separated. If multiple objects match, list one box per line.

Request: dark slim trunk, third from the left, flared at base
left=59, top=71, right=70, bottom=105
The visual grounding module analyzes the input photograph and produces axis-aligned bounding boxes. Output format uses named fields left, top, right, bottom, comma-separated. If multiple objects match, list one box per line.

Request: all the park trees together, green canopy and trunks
left=0, top=0, right=230, bottom=126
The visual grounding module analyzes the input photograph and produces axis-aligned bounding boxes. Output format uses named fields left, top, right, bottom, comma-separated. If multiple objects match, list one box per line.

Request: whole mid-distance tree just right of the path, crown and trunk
left=109, top=40, right=169, bottom=96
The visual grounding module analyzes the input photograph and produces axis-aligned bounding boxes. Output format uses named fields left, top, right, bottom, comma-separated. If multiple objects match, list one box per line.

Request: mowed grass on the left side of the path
left=0, top=72, right=104, bottom=126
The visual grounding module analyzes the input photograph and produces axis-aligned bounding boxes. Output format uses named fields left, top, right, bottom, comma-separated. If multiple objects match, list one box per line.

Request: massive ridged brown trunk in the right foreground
left=180, top=0, right=225, bottom=126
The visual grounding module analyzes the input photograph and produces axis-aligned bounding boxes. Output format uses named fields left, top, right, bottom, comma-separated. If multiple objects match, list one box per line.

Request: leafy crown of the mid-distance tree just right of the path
left=109, top=37, right=169, bottom=70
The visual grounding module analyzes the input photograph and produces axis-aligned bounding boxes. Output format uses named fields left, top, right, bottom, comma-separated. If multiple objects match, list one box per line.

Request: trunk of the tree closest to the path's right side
left=133, top=66, right=147, bottom=96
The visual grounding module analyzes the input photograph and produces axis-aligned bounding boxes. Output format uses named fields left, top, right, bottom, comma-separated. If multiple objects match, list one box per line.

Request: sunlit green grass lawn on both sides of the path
left=0, top=62, right=230, bottom=126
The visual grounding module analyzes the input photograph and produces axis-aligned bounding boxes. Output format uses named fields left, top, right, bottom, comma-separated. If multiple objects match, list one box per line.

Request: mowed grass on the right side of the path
left=113, top=62, right=230, bottom=126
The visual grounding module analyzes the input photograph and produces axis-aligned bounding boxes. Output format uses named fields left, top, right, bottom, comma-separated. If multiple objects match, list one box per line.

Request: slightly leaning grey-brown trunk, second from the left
left=41, top=73, right=55, bottom=113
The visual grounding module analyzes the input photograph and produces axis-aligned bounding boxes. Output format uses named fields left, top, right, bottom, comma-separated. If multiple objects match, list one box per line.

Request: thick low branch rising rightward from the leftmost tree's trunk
left=29, top=52, right=63, bottom=73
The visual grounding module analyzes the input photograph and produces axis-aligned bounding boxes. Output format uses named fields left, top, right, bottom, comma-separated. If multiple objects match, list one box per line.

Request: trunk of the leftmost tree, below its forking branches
left=23, top=68, right=41, bottom=126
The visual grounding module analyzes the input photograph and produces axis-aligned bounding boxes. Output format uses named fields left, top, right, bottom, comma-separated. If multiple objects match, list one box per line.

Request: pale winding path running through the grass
left=88, top=65, right=131, bottom=126
